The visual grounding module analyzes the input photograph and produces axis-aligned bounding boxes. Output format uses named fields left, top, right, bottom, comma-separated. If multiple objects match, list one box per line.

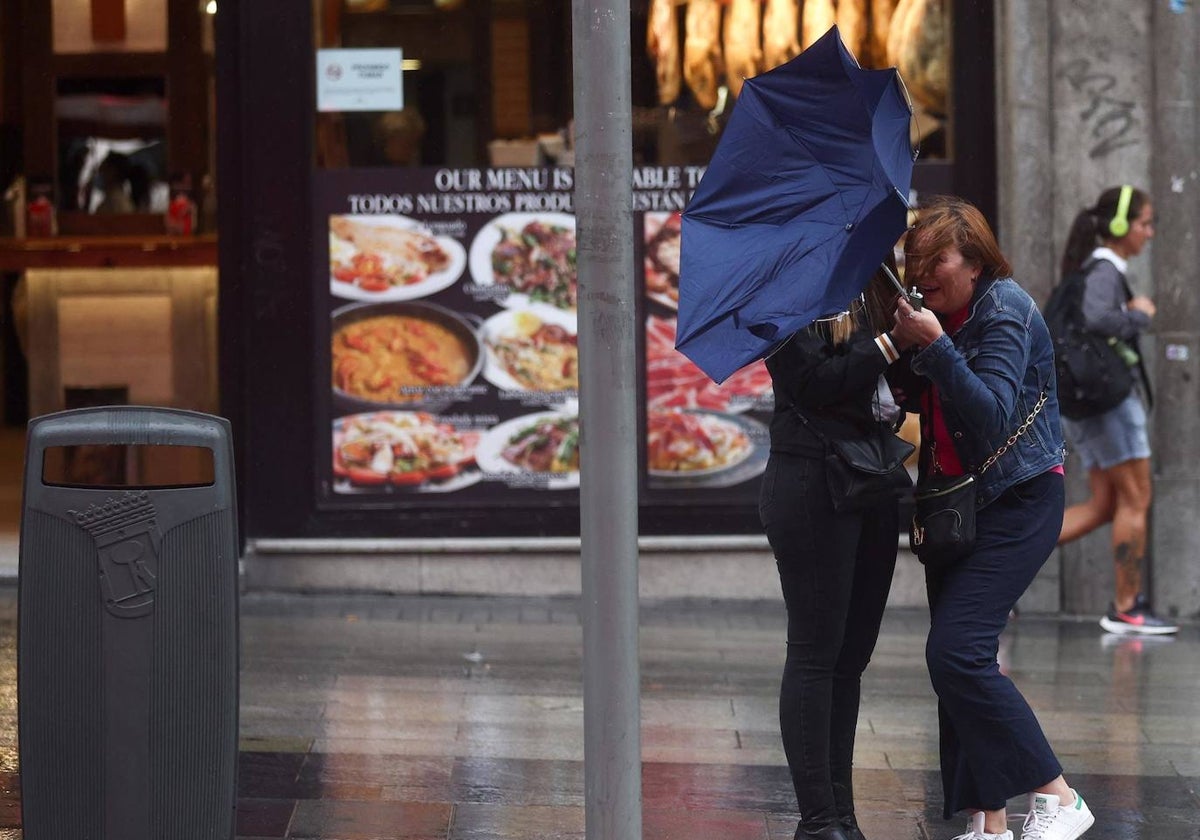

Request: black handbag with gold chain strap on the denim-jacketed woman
left=908, top=391, right=1046, bottom=570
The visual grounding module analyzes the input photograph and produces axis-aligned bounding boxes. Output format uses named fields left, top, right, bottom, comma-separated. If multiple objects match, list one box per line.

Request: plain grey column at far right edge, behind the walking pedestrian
left=1147, top=1, right=1200, bottom=617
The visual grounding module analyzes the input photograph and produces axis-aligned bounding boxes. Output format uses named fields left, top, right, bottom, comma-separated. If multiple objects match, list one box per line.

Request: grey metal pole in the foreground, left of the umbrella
left=572, top=0, right=642, bottom=840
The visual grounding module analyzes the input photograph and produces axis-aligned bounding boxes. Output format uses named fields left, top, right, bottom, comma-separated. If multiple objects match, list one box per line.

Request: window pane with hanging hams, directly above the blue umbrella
left=632, top=0, right=950, bottom=164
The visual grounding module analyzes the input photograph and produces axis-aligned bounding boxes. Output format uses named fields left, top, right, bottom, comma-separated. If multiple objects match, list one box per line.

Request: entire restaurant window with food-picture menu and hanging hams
left=304, top=0, right=969, bottom=532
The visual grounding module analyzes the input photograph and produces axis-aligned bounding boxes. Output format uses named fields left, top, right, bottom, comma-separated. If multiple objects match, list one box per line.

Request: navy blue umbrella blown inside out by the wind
left=676, top=26, right=914, bottom=383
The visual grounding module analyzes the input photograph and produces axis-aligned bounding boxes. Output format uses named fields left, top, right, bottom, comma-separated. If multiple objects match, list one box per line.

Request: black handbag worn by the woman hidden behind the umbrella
left=792, top=406, right=916, bottom=514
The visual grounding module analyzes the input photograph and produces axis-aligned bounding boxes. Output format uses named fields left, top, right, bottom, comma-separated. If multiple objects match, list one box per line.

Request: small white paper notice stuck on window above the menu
left=317, top=49, right=404, bottom=112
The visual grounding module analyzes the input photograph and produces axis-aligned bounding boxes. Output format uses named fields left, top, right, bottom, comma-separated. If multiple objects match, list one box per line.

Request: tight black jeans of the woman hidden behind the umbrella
left=758, top=452, right=900, bottom=827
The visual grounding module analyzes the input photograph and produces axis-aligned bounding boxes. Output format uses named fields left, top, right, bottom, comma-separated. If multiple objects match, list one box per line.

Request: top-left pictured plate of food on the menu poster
left=329, top=216, right=467, bottom=301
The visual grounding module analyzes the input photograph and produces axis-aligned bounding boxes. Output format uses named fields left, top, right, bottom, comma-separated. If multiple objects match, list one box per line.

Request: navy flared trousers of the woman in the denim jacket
left=925, top=473, right=1064, bottom=818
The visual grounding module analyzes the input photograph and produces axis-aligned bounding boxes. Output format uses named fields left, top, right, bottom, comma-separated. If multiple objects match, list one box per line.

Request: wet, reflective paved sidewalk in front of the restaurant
left=0, top=587, right=1200, bottom=840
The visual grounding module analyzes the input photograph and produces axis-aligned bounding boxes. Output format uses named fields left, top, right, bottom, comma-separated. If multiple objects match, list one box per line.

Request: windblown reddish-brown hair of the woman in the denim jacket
left=905, top=196, right=1013, bottom=285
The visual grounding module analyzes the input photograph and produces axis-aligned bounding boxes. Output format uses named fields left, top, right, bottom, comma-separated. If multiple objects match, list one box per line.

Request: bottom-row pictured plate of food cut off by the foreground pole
left=475, top=412, right=580, bottom=490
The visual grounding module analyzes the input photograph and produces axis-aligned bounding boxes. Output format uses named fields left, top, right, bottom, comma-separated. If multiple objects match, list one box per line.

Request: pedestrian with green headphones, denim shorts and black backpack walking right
left=1046, top=185, right=1178, bottom=635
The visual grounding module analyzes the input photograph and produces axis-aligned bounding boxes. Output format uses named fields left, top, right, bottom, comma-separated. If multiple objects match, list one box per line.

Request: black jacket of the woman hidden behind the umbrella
left=767, top=328, right=892, bottom=457
